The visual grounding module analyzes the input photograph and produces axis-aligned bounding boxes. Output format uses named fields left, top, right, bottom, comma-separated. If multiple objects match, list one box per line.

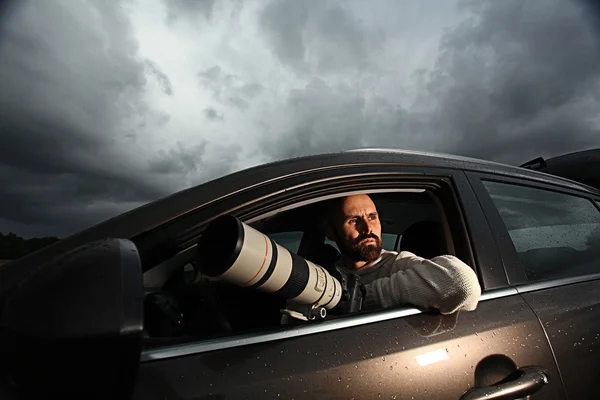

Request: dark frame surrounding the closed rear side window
left=465, top=171, right=600, bottom=293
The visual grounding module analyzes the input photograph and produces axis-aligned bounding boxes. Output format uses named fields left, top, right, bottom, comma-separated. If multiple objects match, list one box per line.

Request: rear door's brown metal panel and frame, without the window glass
left=467, top=173, right=600, bottom=399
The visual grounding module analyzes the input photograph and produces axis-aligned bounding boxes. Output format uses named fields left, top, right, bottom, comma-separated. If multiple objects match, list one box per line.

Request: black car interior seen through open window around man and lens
left=144, top=190, right=460, bottom=347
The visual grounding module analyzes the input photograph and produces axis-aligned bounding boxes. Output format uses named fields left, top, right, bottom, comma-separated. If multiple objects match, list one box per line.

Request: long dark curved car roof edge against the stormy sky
left=0, top=148, right=600, bottom=292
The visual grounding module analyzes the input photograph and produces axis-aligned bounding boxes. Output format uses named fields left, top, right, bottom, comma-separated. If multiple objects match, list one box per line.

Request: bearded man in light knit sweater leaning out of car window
left=326, top=195, right=481, bottom=315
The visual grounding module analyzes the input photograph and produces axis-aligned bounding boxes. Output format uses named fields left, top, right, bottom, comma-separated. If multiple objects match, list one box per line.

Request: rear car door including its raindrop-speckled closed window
left=471, top=175, right=600, bottom=399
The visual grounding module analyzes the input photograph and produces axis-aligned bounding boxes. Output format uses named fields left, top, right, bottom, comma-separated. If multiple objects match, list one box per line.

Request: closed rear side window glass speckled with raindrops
left=483, top=181, right=600, bottom=281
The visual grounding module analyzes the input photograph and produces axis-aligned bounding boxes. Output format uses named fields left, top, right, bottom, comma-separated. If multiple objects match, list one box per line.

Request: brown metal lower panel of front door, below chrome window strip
left=134, top=294, right=564, bottom=400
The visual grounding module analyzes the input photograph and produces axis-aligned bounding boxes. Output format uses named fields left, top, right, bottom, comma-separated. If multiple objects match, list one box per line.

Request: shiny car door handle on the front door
left=461, top=366, right=548, bottom=400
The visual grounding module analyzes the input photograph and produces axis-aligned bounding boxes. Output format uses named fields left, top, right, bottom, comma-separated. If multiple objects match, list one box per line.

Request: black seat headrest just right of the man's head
left=400, top=221, right=448, bottom=259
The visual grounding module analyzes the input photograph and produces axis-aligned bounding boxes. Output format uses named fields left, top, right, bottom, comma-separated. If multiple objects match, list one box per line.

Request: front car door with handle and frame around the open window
left=130, top=165, right=565, bottom=400
